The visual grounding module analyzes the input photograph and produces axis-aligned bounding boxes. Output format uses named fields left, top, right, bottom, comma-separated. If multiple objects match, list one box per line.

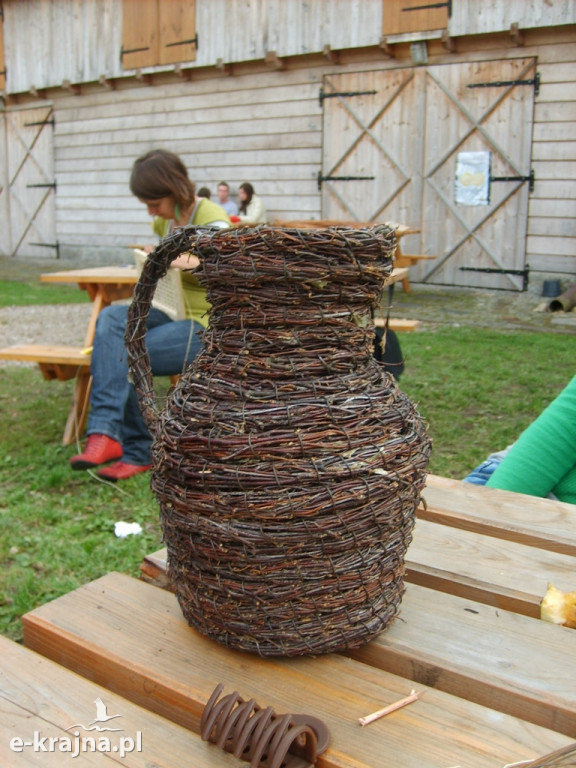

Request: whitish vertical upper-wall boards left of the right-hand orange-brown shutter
left=4, top=0, right=382, bottom=93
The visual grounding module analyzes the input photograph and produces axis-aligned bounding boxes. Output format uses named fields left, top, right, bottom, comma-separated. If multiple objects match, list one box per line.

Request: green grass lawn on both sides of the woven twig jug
left=0, top=283, right=574, bottom=640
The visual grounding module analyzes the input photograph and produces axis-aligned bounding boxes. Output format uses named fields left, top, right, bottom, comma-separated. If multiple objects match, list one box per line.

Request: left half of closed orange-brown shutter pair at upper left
left=122, top=0, right=159, bottom=69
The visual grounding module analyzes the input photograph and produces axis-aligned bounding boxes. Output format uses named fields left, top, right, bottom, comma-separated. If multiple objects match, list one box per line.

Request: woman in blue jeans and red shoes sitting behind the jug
left=70, top=149, right=230, bottom=482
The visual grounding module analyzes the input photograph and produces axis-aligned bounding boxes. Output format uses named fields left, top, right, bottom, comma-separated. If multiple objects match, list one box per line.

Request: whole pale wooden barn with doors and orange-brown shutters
left=0, top=0, right=576, bottom=291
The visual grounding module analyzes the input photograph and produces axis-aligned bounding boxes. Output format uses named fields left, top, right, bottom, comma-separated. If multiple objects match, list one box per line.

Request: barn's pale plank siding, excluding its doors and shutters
left=4, top=0, right=576, bottom=275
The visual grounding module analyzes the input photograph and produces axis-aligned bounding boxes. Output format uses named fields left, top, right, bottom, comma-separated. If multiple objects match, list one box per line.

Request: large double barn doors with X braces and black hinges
left=319, top=59, right=536, bottom=290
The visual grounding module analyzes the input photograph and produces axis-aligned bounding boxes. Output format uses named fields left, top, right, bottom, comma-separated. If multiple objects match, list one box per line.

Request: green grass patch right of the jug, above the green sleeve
left=401, top=327, right=574, bottom=478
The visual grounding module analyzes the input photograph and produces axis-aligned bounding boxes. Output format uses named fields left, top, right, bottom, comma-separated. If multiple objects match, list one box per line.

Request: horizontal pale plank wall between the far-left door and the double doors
left=54, top=70, right=321, bottom=257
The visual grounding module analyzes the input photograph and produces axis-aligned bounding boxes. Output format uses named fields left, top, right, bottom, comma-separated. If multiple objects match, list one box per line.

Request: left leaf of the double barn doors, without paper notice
left=318, top=68, right=424, bottom=234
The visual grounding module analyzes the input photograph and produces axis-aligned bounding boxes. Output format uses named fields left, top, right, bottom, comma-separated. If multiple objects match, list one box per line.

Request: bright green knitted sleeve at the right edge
left=486, top=376, right=576, bottom=504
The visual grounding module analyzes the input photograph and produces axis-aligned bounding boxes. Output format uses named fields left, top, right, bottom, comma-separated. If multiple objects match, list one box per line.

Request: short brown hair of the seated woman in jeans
left=130, top=149, right=196, bottom=210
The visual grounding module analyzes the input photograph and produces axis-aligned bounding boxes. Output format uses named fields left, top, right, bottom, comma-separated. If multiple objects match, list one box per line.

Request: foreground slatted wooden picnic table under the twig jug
left=7, top=476, right=576, bottom=768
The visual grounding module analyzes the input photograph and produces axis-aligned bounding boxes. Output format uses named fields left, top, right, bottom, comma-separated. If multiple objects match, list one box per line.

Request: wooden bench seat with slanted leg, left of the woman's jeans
left=0, top=344, right=92, bottom=445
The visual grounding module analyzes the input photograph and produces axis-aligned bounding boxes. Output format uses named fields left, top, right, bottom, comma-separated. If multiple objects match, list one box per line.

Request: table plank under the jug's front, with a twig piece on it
left=23, top=574, right=569, bottom=768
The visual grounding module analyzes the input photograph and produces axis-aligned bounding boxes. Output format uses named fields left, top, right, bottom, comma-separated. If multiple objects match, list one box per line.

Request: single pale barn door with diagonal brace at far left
left=3, top=107, right=58, bottom=258
